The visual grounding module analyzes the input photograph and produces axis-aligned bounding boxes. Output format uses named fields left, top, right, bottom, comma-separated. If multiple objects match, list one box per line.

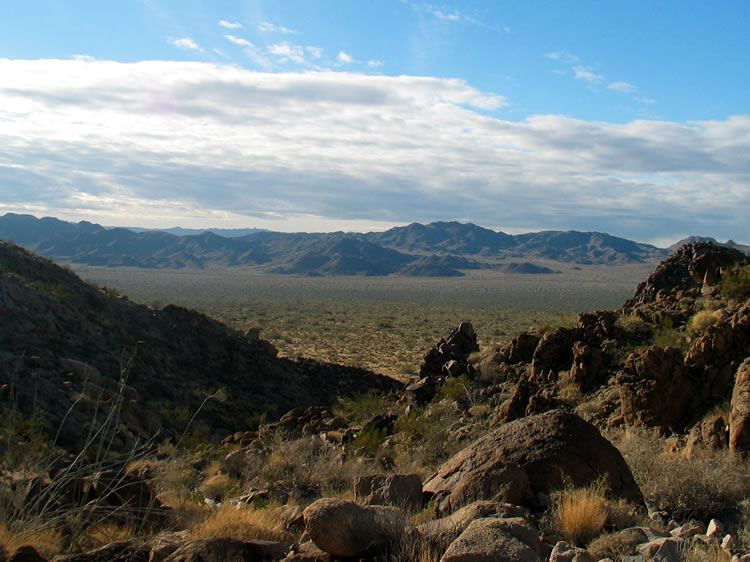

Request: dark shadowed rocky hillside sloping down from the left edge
left=0, top=238, right=406, bottom=450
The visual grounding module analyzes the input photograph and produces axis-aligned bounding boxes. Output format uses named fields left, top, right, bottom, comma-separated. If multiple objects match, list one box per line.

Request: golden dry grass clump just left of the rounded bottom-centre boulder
left=190, top=504, right=291, bottom=541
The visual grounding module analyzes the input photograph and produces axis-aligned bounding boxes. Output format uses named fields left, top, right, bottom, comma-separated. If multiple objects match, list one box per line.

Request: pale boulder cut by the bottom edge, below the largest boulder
left=440, top=517, right=541, bottom=562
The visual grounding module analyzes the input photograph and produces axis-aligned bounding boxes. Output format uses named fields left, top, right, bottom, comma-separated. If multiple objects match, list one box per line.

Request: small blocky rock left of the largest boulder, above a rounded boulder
left=354, top=474, right=422, bottom=511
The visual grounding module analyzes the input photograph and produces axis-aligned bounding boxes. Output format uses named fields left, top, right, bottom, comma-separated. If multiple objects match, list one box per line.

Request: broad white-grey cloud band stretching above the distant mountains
left=0, top=58, right=750, bottom=242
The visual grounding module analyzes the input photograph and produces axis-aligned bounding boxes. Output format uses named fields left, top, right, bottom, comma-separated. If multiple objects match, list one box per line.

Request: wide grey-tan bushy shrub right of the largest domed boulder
left=616, top=432, right=750, bottom=521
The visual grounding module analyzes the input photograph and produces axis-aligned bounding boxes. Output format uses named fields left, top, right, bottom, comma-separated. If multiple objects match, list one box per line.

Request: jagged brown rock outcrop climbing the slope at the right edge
left=482, top=243, right=750, bottom=442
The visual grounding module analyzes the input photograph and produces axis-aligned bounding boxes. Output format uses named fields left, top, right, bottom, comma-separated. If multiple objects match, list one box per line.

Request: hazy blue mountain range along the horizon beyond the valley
left=0, top=213, right=668, bottom=277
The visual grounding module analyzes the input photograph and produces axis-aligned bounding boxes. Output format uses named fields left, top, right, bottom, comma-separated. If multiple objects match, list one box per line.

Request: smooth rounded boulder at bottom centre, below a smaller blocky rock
left=303, top=498, right=407, bottom=558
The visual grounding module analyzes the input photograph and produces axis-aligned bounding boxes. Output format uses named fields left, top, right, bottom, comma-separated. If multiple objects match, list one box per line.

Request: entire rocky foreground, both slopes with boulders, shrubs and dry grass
left=0, top=242, right=750, bottom=562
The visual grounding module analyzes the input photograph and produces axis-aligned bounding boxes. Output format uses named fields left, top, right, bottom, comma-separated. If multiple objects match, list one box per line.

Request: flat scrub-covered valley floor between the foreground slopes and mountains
left=69, top=263, right=653, bottom=379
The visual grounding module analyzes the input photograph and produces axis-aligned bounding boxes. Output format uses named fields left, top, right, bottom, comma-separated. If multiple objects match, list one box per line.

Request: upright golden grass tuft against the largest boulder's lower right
left=552, top=482, right=609, bottom=545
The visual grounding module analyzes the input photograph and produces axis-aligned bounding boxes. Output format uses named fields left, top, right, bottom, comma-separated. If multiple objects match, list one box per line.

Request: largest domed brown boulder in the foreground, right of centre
left=424, top=410, right=643, bottom=513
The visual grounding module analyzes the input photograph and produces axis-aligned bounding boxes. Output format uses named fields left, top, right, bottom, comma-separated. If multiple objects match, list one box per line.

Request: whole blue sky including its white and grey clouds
left=0, top=0, right=750, bottom=246
